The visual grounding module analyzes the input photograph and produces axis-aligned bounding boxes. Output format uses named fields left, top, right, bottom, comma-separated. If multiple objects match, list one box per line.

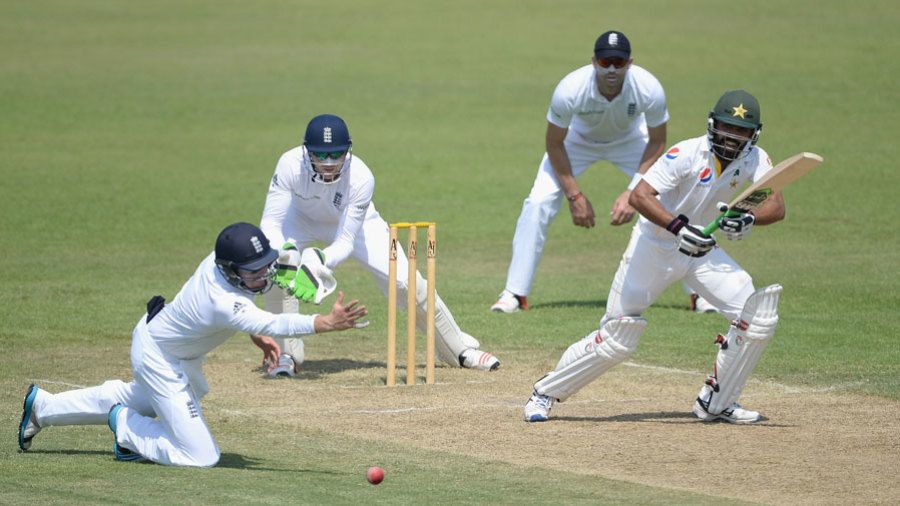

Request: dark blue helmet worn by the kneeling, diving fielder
left=216, top=223, right=278, bottom=294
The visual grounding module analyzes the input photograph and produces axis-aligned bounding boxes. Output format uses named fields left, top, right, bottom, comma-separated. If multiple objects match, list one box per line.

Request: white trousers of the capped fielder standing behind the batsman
left=506, top=127, right=648, bottom=295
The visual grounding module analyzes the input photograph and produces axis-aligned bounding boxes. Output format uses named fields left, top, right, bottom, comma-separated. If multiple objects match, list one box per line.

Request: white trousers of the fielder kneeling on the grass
left=35, top=315, right=220, bottom=467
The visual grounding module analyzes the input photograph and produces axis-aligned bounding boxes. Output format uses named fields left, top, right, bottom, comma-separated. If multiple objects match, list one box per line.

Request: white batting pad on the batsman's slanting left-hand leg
left=534, top=316, right=647, bottom=401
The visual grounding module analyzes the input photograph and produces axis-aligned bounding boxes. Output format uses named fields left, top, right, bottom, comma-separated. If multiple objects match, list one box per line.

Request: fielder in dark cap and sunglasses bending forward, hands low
left=491, top=31, right=684, bottom=313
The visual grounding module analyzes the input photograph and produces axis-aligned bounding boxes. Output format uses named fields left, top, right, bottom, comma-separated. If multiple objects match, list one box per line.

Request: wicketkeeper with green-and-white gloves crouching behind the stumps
left=253, top=114, right=500, bottom=377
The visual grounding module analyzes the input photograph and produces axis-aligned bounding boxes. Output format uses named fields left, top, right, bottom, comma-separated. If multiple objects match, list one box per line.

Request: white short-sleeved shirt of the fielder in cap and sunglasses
left=547, top=65, right=669, bottom=143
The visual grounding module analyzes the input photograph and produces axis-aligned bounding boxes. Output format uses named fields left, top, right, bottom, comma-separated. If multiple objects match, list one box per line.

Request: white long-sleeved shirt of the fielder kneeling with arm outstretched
left=147, top=253, right=315, bottom=360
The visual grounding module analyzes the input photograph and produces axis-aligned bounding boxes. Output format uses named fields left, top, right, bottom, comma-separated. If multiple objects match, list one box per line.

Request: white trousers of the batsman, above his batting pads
left=601, top=225, right=754, bottom=326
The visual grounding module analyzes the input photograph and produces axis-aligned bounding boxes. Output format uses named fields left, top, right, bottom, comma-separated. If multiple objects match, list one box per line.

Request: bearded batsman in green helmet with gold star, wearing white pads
left=525, top=90, right=784, bottom=423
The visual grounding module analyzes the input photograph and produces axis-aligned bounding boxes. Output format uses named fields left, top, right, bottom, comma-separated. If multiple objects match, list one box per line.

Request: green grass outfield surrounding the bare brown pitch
left=0, top=0, right=900, bottom=503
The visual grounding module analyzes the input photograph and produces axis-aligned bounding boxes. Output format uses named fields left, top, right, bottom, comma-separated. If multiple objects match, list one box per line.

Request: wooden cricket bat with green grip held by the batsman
left=703, top=153, right=823, bottom=235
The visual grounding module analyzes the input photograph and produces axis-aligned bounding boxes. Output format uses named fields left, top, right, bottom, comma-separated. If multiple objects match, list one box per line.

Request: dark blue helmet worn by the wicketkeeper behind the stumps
left=303, top=114, right=353, bottom=184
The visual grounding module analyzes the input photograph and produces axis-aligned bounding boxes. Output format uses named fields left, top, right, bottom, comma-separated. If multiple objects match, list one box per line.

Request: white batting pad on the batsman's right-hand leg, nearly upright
left=700, top=285, right=782, bottom=414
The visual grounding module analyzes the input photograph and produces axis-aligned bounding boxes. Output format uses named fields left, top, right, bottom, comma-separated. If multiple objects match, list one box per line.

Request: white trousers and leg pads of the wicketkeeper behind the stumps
left=263, top=208, right=474, bottom=367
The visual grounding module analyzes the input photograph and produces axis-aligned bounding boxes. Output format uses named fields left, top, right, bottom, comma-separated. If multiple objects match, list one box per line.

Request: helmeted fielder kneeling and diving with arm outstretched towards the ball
left=19, top=223, right=367, bottom=467
